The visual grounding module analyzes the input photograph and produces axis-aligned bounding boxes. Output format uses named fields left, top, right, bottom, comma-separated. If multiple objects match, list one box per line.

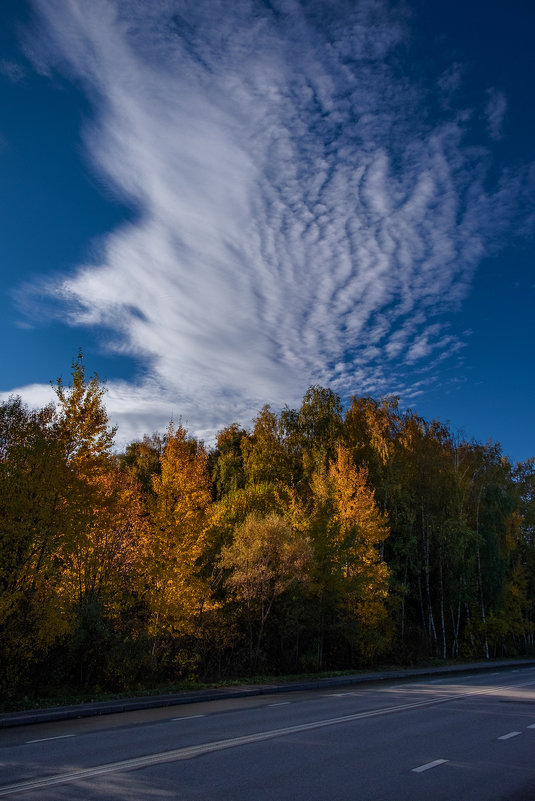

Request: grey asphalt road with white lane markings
left=0, top=667, right=535, bottom=801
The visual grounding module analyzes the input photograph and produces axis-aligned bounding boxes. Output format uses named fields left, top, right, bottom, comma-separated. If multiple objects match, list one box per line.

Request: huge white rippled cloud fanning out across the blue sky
left=16, top=0, right=532, bottom=444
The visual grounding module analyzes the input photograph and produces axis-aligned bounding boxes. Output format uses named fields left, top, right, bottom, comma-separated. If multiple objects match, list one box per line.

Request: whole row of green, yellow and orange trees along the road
left=0, top=354, right=535, bottom=699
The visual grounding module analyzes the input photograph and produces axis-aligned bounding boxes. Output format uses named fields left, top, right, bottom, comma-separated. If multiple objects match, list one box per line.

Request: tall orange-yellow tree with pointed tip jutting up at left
left=49, top=352, right=147, bottom=686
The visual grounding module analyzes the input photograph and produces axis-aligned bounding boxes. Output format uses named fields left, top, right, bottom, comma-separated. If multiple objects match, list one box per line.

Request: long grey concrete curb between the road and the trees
left=0, top=659, right=535, bottom=728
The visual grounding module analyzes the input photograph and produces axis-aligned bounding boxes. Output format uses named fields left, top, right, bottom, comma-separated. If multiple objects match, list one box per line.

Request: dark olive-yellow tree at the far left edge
left=0, top=397, right=72, bottom=694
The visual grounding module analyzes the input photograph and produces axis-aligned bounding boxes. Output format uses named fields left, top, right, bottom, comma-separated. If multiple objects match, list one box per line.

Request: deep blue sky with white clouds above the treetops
left=0, top=0, right=535, bottom=461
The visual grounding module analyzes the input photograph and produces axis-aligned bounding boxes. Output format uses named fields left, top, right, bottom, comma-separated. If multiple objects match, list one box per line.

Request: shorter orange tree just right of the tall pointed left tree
left=57, top=468, right=149, bottom=689
